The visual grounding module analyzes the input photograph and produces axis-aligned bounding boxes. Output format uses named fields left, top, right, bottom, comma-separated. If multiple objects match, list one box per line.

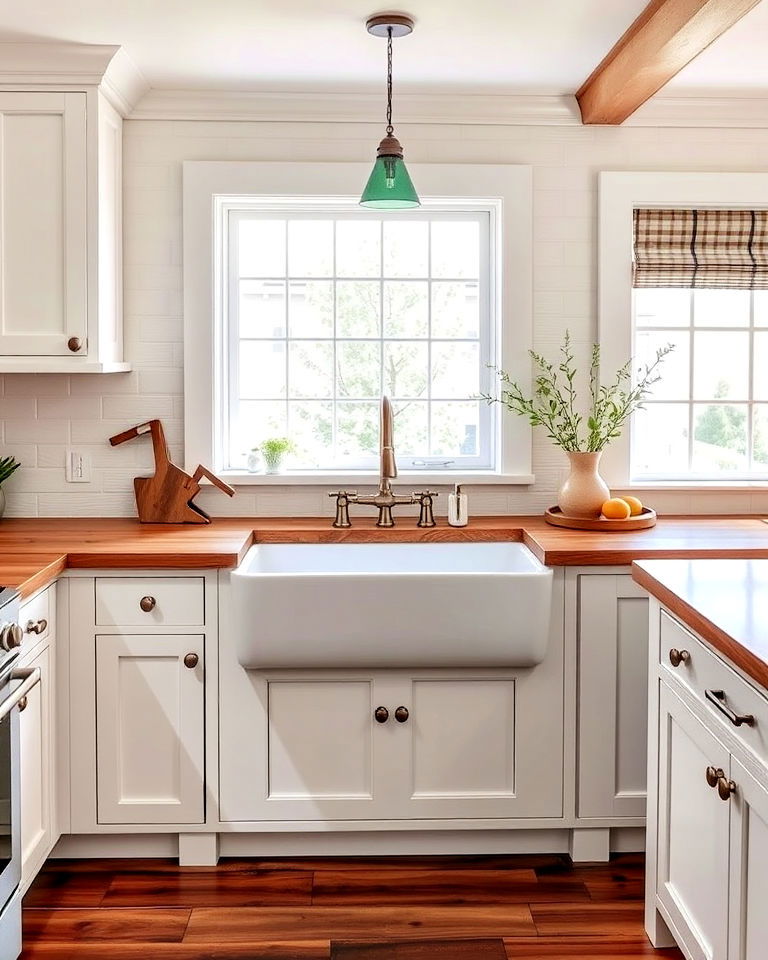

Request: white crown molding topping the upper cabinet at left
left=0, top=42, right=149, bottom=116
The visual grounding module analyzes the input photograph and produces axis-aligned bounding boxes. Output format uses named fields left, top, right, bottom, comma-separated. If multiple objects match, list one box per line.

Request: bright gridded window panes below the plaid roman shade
left=630, top=288, right=768, bottom=481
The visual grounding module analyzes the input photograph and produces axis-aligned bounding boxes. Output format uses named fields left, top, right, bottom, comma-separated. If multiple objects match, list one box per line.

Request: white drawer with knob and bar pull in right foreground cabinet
left=659, top=610, right=768, bottom=762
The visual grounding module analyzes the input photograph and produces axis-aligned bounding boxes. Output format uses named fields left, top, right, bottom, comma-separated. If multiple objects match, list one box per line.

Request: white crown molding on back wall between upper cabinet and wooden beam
left=131, top=90, right=581, bottom=126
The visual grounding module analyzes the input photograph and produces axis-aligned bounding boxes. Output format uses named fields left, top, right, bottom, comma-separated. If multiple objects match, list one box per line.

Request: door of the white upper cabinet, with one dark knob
left=0, top=92, right=87, bottom=356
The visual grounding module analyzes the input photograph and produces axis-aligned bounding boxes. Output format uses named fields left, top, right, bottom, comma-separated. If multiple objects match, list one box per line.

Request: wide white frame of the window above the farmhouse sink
left=183, top=161, right=534, bottom=485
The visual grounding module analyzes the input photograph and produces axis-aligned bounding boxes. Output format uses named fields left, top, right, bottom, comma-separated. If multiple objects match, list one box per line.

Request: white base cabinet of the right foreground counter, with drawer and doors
left=646, top=601, right=768, bottom=960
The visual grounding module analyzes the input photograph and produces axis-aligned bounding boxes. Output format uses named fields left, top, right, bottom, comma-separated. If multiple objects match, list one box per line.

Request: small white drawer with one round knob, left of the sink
left=96, top=577, right=205, bottom=627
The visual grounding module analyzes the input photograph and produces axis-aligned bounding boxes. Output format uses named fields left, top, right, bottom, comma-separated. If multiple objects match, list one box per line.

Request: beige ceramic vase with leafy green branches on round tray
left=482, top=331, right=673, bottom=517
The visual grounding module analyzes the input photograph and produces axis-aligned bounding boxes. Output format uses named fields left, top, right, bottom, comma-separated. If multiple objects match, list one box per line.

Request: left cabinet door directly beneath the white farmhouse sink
left=220, top=671, right=395, bottom=820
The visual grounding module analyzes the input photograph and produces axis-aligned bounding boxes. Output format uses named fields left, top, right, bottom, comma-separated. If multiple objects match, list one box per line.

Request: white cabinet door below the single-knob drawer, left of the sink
left=96, top=635, right=204, bottom=823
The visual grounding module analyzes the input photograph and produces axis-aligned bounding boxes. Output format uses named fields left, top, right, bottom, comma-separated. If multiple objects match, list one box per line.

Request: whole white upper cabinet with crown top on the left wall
left=0, top=43, right=147, bottom=373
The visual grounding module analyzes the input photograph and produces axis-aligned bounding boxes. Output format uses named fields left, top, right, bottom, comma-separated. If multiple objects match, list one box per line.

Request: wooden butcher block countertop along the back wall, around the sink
left=0, top=516, right=768, bottom=596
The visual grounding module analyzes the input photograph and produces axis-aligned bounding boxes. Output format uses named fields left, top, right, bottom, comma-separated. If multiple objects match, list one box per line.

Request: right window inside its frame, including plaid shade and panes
left=631, top=209, right=768, bottom=481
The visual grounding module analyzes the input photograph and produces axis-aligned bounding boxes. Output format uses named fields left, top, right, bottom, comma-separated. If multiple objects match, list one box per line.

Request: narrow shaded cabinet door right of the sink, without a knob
left=578, top=574, right=648, bottom=818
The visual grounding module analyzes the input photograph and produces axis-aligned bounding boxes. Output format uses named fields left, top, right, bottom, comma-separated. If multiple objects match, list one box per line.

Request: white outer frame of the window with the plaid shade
left=598, top=171, right=768, bottom=490
